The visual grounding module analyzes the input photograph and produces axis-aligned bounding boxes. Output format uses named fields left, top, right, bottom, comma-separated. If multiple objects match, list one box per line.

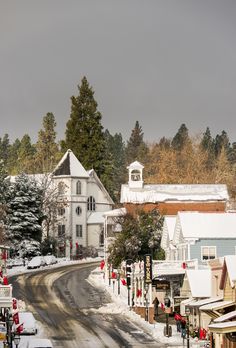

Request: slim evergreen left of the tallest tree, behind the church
left=36, top=112, right=59, bottom=173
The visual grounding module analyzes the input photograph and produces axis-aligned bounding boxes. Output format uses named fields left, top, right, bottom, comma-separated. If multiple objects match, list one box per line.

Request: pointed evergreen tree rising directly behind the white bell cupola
left=125, top=121, right=148, bottom=165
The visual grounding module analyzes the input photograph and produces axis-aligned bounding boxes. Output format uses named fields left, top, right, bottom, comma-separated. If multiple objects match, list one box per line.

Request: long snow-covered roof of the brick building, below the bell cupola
left=120, top=184, right=229, bottom=204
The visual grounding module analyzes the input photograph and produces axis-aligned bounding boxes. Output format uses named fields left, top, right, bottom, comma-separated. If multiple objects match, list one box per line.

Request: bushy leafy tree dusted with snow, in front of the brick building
left=109, top=209, right=163, bottom=267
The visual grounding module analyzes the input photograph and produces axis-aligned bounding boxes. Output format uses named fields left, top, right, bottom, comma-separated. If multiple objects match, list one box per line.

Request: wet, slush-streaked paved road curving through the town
left=11, top=264, right=170, bottom=348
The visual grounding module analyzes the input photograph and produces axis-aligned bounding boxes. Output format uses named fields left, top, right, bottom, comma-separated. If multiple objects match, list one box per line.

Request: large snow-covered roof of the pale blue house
left=173, top=212, right=236, bottom=244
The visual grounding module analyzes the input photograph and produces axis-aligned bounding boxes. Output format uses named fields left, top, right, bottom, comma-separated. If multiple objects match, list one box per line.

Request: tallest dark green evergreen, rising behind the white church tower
left=61, top=77, right=112, bottom=190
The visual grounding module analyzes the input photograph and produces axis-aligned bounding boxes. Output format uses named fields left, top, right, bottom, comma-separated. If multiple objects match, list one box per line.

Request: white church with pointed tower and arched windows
left=52, top=150, right=114, bottom=255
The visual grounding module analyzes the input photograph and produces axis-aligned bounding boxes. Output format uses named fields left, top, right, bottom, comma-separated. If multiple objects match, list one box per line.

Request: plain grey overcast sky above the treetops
left=0, top=0, right=236, bottom=142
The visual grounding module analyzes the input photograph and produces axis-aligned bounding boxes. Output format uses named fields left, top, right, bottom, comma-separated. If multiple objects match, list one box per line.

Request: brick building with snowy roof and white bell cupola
left=120, top=161, right=229, bottom=215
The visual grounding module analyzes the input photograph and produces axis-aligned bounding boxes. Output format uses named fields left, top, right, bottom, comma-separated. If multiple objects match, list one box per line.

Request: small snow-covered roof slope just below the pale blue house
left=186, top=269, right=211, bottom=297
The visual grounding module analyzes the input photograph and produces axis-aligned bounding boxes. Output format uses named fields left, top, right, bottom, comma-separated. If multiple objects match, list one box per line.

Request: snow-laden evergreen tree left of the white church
left=6, top=174, right=44, bottom=243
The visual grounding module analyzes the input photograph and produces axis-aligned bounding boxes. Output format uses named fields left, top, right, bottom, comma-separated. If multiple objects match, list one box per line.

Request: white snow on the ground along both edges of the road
left=5, top=258, right=206, bottom=348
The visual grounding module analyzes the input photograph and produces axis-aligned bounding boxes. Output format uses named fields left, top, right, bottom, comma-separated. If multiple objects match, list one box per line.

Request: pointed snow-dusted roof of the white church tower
left=53, top=150, right=89, bottom=178
